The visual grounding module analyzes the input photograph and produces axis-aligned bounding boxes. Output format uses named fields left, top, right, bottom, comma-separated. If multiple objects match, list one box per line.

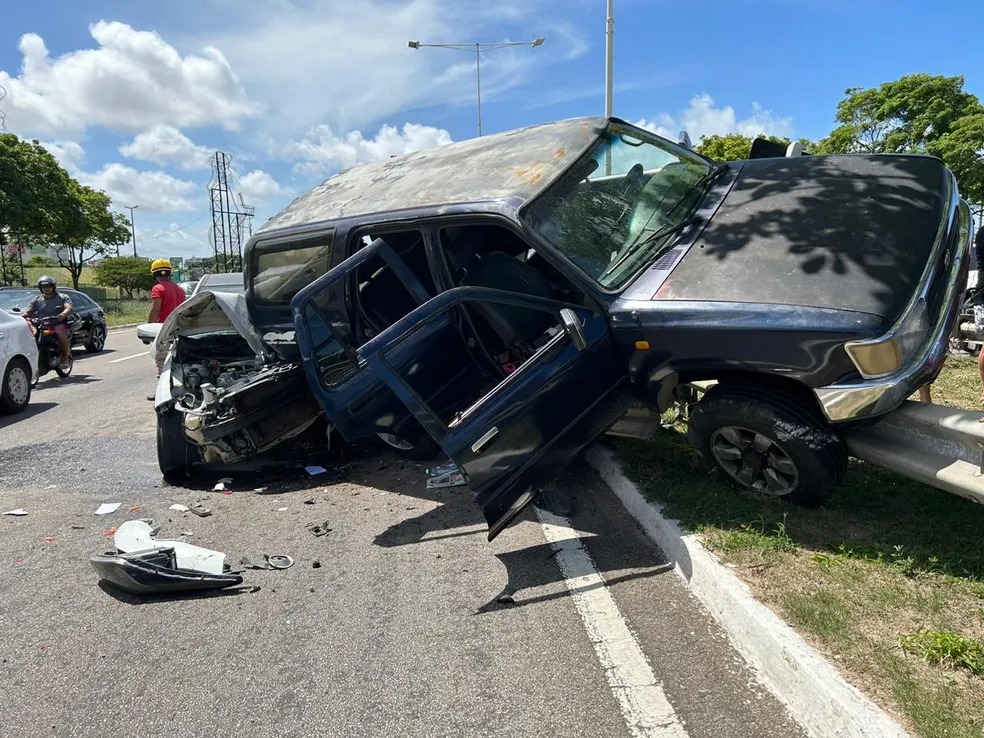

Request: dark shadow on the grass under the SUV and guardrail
left=612, top=431, right=984, bottom=579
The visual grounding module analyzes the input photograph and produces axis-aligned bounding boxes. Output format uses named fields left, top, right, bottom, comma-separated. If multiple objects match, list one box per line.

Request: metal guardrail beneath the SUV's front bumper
left=845, top=400, right=984, bottom=504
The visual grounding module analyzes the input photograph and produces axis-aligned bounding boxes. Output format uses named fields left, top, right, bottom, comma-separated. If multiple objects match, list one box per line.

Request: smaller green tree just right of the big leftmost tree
left=52, top=180, right=130, bottom=289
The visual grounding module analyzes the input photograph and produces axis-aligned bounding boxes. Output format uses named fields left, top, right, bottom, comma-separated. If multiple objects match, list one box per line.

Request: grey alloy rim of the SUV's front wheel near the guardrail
left=711, top=425, right=799, bottom=497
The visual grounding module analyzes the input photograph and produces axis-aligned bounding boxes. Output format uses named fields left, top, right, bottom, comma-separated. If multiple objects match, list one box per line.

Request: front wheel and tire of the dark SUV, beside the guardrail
left=688, top=384, right=847, bottom=507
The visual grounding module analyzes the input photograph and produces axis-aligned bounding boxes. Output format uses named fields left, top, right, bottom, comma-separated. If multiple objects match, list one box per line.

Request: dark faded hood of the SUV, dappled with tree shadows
left=648, top=155, right=952, bottom=322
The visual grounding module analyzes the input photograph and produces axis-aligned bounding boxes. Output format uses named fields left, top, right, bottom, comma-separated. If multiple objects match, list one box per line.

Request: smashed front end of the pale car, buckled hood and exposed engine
left=155, top=294, right=321, bottom=463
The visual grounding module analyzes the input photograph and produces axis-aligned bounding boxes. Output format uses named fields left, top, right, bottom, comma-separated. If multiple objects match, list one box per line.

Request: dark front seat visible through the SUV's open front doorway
left=461, top=251, right=555, bottom=348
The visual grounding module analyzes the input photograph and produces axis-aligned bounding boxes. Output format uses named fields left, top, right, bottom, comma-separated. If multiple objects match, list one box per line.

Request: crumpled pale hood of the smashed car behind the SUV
left=150, top=292, right=268, bottom=360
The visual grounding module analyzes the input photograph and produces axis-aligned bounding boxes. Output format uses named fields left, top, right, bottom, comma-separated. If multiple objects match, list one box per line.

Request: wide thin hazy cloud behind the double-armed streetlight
left=189, top=0, right=552, bottom=134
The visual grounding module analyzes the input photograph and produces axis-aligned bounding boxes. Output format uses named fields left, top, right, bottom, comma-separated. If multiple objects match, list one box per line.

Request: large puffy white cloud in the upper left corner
left=0, top=21, right=258, bottom=132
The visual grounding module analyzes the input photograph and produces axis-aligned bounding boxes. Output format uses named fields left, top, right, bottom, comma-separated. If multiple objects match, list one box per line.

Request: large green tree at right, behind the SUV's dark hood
left=818, top=74, right=984, bottom=202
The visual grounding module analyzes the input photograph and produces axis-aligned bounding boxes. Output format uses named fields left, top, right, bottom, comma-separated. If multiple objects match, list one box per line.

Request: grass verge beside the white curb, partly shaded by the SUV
left=613, top=357, right=984, bottom=738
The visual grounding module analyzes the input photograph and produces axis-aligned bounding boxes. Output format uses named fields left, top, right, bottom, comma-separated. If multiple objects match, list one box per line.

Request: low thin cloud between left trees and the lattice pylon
left=79, top=163, right=198, bottom=213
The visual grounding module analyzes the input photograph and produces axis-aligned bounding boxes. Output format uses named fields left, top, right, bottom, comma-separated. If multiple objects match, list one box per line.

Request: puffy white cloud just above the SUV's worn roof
left=281, top=123, right=451, bottom=174
